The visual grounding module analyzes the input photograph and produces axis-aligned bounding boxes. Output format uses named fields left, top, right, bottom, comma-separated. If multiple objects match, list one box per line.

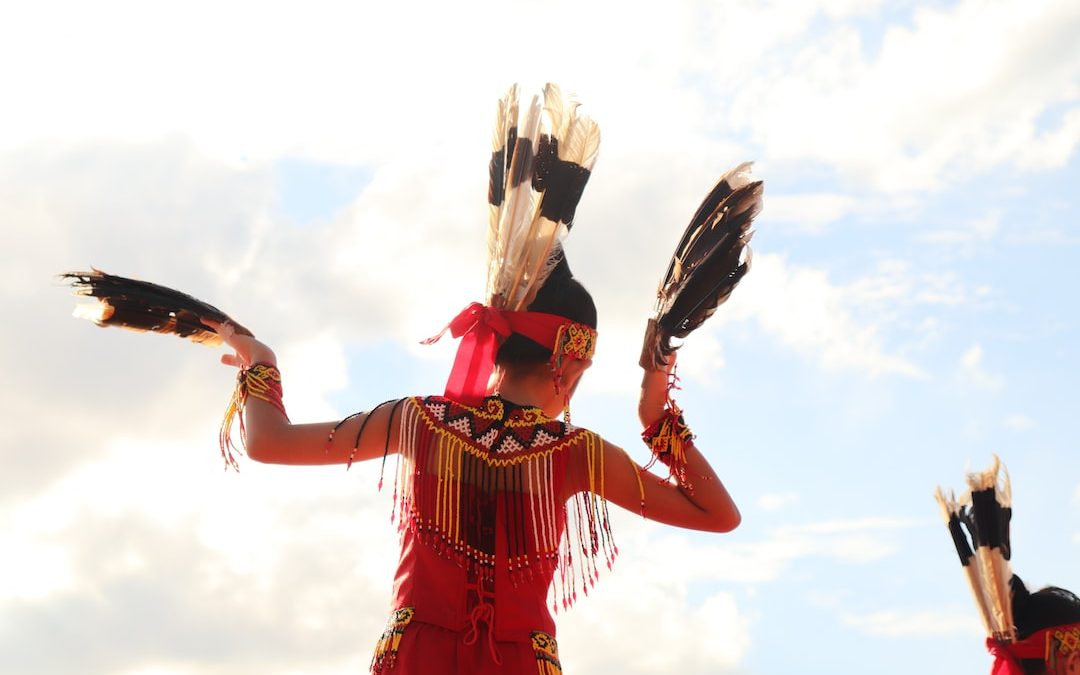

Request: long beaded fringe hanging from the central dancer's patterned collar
left=391, top=399, right=618, bottom=611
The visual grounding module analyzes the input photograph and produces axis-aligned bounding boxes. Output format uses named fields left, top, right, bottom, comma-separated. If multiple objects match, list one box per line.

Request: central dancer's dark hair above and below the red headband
left=495, top=256, right=596, bottom=367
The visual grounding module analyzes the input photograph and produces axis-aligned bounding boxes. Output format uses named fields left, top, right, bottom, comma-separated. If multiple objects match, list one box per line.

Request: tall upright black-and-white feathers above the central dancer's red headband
left=487, top=83, right=599, bottom=310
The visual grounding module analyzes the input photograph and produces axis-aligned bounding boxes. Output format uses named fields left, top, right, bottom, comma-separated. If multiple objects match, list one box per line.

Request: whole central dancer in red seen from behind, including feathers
left=69, top=84, right=760, bottom=675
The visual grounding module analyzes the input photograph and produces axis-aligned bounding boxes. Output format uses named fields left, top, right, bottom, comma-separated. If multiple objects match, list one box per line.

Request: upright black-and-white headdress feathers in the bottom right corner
left=934, top=456, right=1016, bottom=644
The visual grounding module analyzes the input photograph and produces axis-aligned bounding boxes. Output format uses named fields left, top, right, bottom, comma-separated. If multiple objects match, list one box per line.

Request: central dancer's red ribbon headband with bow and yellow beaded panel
left=423, top=302, right=596, bottom=405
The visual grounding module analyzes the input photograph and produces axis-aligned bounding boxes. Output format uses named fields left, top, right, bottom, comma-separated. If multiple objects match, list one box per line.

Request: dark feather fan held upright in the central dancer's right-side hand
left=642, top=162, right=764, bottom=368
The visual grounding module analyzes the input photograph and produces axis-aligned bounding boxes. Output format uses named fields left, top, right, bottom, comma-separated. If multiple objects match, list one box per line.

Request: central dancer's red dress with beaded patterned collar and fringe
left=372, top=396, right=616, bottom=675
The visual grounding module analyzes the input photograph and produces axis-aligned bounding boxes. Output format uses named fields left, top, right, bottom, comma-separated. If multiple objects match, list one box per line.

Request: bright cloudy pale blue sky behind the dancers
left=0, top=0, right=1080, bottom=675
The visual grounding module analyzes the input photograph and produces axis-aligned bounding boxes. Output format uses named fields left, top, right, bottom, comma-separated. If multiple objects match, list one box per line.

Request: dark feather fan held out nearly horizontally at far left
left=60, top=268, right=252, bottom=346
